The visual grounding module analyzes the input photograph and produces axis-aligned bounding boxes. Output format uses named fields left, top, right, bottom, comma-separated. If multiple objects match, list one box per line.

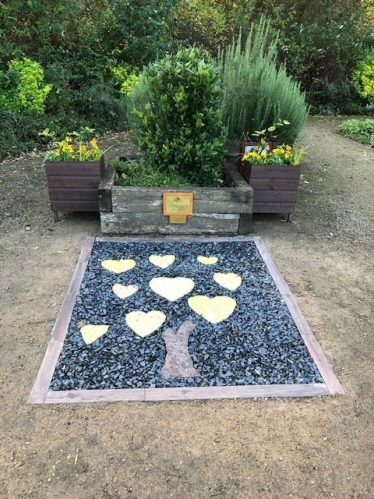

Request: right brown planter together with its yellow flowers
left=241, top=141, right=305, bottom=221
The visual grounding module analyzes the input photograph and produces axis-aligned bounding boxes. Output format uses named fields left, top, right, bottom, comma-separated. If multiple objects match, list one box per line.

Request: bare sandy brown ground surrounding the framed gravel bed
left=0, top=117, right=374, bottom=499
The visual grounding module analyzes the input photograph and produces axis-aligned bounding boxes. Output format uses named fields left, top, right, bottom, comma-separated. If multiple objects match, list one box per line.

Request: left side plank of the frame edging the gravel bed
left=27, top=237, right=95, bottom=404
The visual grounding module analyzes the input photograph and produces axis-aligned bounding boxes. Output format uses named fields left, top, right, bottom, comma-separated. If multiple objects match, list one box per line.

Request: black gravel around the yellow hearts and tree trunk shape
left=50, top=241, right=323, bottom=390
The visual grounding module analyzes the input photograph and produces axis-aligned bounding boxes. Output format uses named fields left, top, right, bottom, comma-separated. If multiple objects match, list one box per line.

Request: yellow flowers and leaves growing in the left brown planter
left=45, top=127, right=105, bottom=161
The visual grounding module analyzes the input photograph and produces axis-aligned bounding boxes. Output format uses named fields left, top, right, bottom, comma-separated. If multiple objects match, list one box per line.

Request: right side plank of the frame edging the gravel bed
left=253, top=237, right=344, bottom=395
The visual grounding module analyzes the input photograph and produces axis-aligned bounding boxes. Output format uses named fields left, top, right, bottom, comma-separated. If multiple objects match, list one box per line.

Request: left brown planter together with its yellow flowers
left=43, top=127, right=105, bottom=221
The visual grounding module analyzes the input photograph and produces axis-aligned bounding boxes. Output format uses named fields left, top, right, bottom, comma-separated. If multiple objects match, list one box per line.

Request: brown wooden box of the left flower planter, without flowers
left=45, top=157, right=105, bottom=221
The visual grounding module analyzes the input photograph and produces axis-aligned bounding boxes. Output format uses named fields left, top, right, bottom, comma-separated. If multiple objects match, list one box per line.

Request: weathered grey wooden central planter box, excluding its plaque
left=99, top=164, right=253, bottom=235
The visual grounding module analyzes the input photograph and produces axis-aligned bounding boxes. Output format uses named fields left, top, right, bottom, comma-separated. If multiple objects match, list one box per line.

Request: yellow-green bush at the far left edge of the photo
left=0, top=59, right=52, bottom=114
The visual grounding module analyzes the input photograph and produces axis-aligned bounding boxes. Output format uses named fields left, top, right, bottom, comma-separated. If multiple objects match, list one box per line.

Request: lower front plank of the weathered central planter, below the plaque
left=100, top=213, right=239, bottom=235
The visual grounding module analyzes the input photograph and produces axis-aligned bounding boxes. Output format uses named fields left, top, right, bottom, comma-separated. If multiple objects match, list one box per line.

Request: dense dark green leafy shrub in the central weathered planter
left=133, top=48, right=226, bottom=185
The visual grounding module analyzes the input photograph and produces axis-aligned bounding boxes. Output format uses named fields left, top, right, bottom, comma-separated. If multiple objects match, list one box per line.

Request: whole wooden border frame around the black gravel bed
left=27, top=236, right=344, bottom=404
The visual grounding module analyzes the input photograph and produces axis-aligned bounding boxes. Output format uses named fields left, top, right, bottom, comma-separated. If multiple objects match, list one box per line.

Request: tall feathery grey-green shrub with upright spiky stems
left=220, top=18, right=307, bottom=144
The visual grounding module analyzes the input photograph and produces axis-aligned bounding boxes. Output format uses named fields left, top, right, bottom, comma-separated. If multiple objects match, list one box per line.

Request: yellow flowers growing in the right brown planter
left=242, top=142, right=305, bottom=165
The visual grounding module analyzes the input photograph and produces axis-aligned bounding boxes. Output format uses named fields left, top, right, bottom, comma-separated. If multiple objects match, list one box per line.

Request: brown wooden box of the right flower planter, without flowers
left=241, top=162, right=301, bottom=219
